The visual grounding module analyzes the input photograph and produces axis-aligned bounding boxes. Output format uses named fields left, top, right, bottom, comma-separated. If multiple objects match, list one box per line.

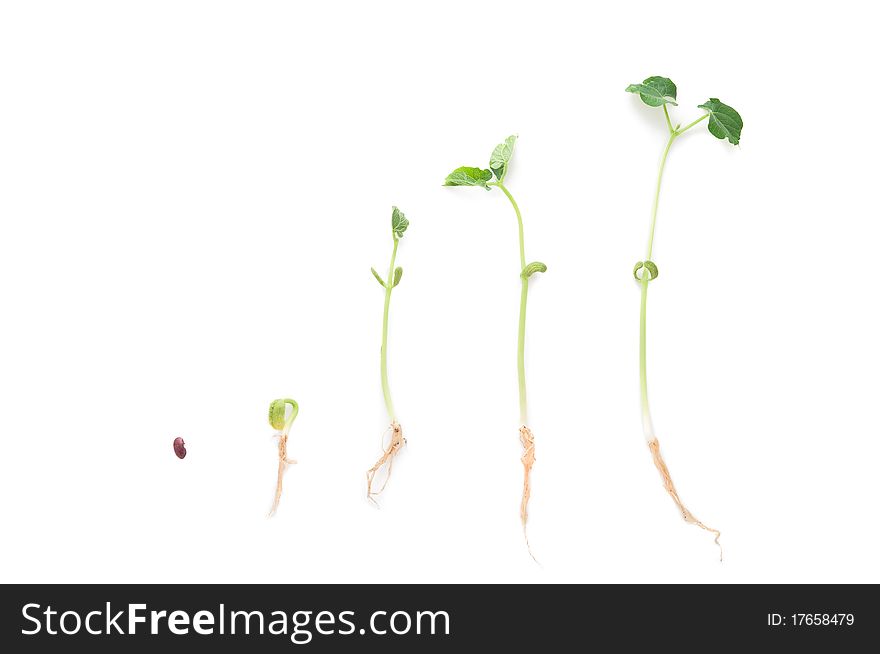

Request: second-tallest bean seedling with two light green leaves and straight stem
left=444, top=136, right=547, bottom=543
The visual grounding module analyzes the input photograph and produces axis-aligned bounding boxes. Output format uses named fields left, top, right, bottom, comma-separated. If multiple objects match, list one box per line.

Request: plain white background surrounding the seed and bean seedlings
left=0, top=1, right=880, bottom=582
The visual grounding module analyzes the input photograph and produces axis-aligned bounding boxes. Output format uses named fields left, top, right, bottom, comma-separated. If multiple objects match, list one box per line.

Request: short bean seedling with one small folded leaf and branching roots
left=367, top=207, right=409, bottom=501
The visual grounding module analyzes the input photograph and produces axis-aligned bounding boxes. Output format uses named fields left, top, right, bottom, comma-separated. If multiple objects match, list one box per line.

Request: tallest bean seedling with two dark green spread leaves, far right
left=626, top=77, right=743, bottom=560
